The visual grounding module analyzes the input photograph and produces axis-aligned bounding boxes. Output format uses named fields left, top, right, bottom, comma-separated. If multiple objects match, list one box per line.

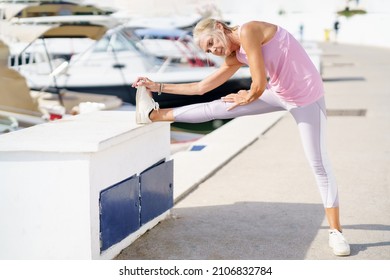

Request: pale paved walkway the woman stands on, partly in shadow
left=117, top=43, right=390, bottom=260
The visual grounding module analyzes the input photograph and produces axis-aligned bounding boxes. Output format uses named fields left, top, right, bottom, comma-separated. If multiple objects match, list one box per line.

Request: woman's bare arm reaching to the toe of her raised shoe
left=132, top=54, right=242, bottom=95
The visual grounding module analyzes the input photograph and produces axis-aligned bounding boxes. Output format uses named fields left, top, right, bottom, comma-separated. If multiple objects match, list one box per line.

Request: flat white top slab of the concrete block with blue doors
left=0, top=111, right=169, bottom=153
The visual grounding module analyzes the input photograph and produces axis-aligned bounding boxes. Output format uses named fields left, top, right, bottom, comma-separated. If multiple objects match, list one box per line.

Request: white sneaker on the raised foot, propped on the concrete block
left=135, top=86, right=159, bottom=124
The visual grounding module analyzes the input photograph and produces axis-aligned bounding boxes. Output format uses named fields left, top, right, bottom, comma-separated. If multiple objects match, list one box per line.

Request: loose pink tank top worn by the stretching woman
left=236, top=26, right=324, bottom=106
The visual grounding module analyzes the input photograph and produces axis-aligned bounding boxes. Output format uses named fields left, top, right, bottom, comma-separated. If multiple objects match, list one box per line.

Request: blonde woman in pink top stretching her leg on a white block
left=133, top=19, right=350, bottom=256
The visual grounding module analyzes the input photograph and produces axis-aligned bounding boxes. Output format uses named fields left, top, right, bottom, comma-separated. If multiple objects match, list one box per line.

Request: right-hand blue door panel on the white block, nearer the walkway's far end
left=140, top=160, right=173, bottom=225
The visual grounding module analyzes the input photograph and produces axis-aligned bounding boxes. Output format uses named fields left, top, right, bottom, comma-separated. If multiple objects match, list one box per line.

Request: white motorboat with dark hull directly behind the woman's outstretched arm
left=12, top=21, right=251, bottom=108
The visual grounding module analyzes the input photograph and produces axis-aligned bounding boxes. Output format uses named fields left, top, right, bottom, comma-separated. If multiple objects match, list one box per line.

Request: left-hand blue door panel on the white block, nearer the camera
left=100, top=176, right=140, bottom=251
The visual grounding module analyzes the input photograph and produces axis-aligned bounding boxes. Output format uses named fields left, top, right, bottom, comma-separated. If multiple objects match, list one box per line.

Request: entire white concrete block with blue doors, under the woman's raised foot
left=0, top=111, right=173, bottom=259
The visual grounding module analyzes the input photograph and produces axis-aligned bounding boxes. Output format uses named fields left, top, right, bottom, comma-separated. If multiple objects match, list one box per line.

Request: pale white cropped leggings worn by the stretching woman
left=173, top=90, right=339, bottom=208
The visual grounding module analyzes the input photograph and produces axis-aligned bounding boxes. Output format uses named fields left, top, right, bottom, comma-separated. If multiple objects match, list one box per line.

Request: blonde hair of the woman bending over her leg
left=193, top=18, right=238, bottom=51
